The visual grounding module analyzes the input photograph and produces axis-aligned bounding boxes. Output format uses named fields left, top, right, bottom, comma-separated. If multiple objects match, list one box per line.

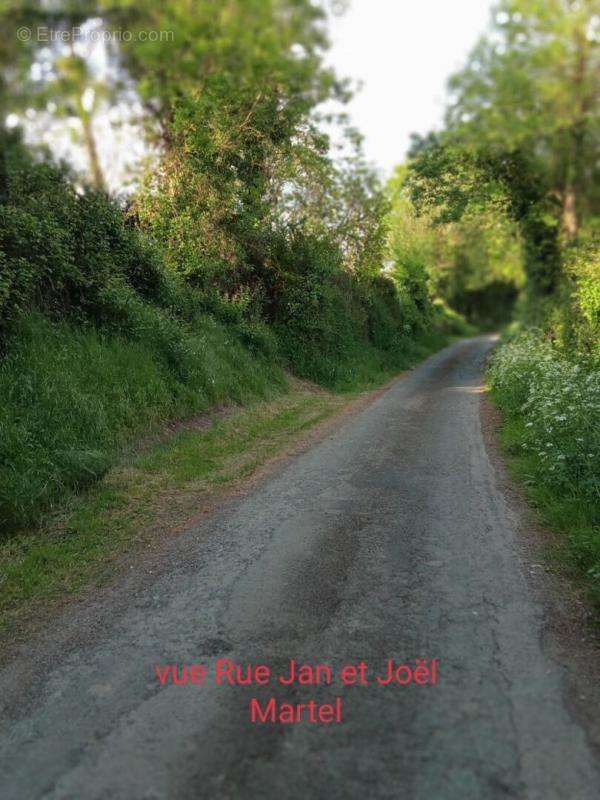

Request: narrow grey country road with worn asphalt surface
left=0, top=337, right=600, bottom=800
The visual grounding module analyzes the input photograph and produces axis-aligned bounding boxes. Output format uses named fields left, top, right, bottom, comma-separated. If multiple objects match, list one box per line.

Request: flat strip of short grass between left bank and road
left=0, top=384, right=348, bottom=628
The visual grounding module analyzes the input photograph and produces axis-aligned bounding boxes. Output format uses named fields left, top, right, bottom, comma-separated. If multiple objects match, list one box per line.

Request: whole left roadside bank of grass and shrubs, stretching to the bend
left=0, top=115, right=454, bottom=532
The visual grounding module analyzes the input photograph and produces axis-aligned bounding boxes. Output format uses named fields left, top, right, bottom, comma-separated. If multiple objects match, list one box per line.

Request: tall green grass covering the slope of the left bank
left=0, top=313, right=285, bottom=533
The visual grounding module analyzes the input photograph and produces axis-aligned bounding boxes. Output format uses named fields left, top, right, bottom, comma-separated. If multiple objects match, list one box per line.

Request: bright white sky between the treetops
left=328, top=0, right=493, bottom=175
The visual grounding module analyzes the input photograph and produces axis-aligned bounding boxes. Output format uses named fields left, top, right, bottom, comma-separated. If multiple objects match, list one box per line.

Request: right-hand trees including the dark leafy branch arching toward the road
left=410, top=0, right=600, bottom=324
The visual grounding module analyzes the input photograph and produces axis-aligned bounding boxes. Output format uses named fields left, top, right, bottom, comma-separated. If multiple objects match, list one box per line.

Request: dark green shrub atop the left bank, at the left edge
left=0, top=135, right=191, bottom=336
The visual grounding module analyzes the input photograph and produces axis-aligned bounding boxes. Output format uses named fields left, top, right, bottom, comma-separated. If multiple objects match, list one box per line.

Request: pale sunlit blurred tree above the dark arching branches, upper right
left=447, top=0, right=600, bottom=240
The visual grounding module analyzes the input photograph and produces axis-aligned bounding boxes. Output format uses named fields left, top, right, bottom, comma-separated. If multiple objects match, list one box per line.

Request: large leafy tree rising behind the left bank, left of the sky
left=106, top=0, right=343, bottom=296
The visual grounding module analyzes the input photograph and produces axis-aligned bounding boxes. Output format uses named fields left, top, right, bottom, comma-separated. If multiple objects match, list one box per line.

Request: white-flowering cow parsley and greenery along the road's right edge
left=488, top=332, right=600, bottom=602
